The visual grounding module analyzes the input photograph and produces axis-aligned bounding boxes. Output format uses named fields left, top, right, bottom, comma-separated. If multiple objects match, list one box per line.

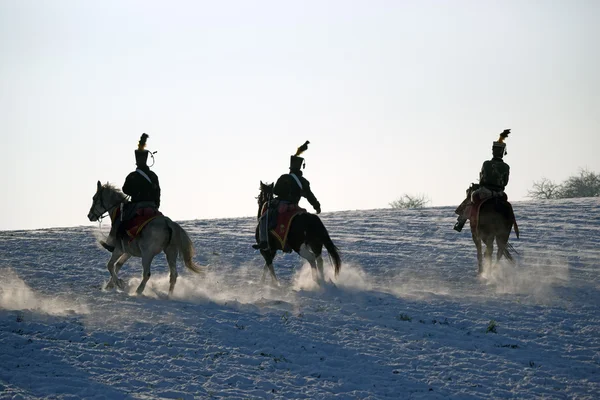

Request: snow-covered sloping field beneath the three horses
left=0, top=198, right=600, bottom=399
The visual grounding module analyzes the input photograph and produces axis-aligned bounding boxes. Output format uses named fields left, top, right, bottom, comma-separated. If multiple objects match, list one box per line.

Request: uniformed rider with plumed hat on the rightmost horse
left=454, top=129, right=510, bottom=232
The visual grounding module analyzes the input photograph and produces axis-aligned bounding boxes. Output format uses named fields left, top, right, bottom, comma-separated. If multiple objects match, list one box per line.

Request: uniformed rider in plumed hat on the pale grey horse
left=100, top=133, right=160, bottom=252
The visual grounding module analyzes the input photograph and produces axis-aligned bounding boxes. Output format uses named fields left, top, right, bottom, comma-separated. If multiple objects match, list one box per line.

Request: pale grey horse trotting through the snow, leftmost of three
left=88, top=181, right=202, bottom=295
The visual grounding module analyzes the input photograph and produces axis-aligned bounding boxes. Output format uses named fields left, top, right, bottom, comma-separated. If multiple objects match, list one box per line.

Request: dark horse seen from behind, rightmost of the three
left=467, top=184, right=519, bottom=274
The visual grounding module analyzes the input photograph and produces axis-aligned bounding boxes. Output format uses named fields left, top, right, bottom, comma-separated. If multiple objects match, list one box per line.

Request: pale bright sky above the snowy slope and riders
left=0, top=0, right=600, bottom=230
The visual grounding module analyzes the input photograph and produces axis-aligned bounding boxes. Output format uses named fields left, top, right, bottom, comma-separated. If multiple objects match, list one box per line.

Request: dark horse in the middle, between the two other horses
left=256, top=182, right=342, bottom=283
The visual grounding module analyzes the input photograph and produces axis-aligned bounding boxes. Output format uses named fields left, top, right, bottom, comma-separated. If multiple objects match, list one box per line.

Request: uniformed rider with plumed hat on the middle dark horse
left=253, top=140, right=321, bottom=250
